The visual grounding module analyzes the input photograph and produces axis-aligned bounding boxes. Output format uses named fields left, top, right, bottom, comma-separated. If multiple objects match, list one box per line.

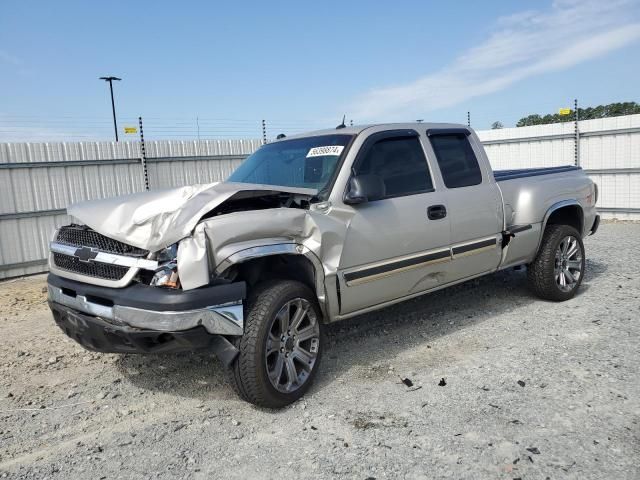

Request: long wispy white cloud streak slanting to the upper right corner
left=349, top=0, right=640, bottom=121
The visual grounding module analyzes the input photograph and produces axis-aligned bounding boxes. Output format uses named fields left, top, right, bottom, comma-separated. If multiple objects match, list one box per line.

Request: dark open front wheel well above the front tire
left=227, top=254, right=316, bottom=295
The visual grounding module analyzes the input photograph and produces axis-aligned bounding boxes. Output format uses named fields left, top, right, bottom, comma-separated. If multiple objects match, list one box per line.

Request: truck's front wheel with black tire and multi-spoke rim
left=229, top=280, right=322, bottom=408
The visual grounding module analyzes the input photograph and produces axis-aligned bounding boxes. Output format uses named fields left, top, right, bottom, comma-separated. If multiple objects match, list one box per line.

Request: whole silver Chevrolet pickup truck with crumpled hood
left=48, top=123, right=599, bottom=407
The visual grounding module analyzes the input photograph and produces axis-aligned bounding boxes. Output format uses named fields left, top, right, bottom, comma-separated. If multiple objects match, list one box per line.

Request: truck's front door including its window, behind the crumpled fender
left=338, top=130, right=450, bottom=314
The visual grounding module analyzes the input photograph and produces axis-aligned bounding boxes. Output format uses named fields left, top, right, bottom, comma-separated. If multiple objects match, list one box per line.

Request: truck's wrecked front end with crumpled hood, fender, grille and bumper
left=48, top=183, right=344, bottom=363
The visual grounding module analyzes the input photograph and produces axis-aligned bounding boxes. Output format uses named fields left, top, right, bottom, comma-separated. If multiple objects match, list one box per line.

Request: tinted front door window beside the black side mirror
left=355, top=137, right=433, bottom=198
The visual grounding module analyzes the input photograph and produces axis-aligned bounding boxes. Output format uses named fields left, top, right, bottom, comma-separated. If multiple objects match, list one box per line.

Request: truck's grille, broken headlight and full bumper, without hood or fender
left=48, top=225, right=246, bottom=363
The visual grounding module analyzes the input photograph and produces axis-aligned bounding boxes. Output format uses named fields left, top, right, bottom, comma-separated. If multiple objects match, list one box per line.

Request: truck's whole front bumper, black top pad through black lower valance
left=48, top=274, right=246, bottom=363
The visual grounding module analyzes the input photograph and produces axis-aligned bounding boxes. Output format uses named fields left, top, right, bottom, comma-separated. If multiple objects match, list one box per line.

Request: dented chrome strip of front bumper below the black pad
left=48, top=285, right=244, bottom=335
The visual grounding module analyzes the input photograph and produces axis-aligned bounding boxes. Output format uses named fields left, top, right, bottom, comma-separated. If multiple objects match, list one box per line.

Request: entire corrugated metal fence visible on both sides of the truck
left=0, top=115, right=640, bottom=278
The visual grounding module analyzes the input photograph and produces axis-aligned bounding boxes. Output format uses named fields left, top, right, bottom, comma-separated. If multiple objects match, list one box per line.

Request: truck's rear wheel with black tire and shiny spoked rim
left=527, top=225, right=585, bottom=302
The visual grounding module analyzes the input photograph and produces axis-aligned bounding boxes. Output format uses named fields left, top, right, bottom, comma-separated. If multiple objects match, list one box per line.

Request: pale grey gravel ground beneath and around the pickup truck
left=0, top=224, right=640, bottom=480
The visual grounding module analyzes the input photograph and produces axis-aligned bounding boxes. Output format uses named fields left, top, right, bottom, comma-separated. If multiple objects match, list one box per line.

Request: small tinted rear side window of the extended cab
left=429, top=133, right=482, bottom=188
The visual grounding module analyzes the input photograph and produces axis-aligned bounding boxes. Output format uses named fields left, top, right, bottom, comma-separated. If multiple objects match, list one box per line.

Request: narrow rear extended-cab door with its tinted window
left=427, top=128, right=503, bottom=280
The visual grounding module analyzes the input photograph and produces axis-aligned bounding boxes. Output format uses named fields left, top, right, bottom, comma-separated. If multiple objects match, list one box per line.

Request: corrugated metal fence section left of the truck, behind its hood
left=0, top=139, right=261, bottom=278
